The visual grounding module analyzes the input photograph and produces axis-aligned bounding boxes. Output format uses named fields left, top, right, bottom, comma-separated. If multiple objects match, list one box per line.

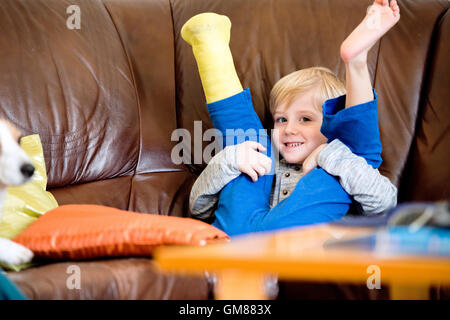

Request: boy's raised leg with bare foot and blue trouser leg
left=321, top=0, right=400, bottom=168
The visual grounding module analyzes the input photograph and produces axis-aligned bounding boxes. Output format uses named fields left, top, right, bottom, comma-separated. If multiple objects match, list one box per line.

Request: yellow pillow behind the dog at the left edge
left=0, top=134, right=58, bottom=269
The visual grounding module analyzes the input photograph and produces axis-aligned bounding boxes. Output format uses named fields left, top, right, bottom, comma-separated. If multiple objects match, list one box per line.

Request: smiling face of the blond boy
left=273, top=88, right=327, bottom=164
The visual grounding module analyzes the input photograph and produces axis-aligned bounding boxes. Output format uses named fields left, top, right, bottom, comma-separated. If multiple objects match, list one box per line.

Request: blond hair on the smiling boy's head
left=270, top=67, right=345, bottom=115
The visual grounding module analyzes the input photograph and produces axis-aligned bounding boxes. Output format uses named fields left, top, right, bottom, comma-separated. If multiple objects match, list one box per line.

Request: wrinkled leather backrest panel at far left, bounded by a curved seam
left=0, top=0, right=139, bottom=187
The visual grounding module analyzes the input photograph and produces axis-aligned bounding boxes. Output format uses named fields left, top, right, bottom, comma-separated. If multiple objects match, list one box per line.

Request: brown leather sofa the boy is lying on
left=0, top=0, right=450, bottom=299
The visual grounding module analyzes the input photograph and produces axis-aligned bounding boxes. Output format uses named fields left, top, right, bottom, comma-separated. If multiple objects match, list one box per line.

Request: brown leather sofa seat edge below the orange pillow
left=8, top=258, right=211, bottom=300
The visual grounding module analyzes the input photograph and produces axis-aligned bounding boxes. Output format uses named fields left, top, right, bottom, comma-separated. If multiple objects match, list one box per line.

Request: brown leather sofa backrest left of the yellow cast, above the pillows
left=0, top=0, right=192, bottom=215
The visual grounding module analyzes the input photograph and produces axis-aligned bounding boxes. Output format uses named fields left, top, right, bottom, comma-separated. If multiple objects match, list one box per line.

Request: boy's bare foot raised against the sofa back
left=341, top=0, right=400, bottom=63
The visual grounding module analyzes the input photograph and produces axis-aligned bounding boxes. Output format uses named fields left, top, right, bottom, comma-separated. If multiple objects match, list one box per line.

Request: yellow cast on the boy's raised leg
left=181, top=12, right=243, bottom=103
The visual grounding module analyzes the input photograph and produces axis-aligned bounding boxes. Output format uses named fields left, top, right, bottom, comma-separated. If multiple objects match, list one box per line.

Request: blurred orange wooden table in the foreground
left=154, top=224, right=450, bottom=299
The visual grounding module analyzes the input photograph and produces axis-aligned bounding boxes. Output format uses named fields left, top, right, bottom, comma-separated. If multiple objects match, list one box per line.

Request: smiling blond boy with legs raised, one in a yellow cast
left=182, top=0, right=400, bottom=235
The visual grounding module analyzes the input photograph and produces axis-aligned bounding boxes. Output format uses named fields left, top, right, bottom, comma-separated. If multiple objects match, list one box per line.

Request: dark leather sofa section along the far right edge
left=400, top=10, right=450, bottom=201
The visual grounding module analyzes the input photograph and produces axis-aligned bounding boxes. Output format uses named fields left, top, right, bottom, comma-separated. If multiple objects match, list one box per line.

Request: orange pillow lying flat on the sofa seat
left=13, top=205, right=229, bottom=259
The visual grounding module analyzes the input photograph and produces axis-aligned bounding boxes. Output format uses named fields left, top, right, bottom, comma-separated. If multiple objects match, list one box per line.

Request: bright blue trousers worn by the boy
left=204, top=89, right=381, bottom=235
